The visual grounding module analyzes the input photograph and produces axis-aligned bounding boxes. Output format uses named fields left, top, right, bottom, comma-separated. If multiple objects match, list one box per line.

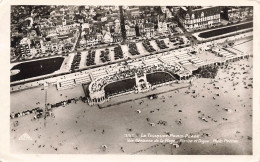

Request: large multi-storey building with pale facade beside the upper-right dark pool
left=179, top=6, right=221, bottom=31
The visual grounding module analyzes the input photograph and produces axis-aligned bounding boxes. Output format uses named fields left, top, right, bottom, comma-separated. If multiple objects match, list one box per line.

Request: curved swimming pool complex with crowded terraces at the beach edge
left=84, top=62, right=192, bottom=105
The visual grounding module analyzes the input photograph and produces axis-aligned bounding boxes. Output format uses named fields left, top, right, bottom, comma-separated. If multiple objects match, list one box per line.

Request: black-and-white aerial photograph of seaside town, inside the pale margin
left=10, top=5, right=254, bottom=155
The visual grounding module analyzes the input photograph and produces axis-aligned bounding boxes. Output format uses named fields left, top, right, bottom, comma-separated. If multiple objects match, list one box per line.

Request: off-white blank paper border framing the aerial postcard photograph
left=0, top=0, right=260, bottom=162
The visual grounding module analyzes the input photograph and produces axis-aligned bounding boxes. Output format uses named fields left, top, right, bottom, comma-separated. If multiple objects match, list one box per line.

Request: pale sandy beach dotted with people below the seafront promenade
left=10, top=41, right=253, bottom=155
